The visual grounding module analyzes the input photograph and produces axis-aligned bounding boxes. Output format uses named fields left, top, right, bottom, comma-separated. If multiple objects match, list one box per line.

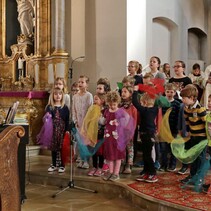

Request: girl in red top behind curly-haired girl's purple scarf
left=120, top=86, right=137, bottom=174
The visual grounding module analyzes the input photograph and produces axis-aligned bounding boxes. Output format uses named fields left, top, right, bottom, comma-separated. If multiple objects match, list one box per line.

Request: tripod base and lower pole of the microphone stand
left=52, top=132, right=97, bottom=198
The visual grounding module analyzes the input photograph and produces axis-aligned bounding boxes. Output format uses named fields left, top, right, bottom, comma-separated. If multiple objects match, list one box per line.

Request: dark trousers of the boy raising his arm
left=141, top=133, right=156, bottom=175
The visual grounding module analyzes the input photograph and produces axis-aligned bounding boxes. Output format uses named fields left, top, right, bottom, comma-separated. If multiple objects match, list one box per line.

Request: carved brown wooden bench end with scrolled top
left=0, top=126, right=25, bottom=211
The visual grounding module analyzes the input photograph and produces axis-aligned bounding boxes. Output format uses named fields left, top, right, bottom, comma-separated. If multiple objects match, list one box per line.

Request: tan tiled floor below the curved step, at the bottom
left=21, top=184, right=141, bottom=211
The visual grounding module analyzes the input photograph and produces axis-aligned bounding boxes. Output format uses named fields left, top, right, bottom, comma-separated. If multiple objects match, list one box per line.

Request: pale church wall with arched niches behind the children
left=68, top=0, right=211, bottom=90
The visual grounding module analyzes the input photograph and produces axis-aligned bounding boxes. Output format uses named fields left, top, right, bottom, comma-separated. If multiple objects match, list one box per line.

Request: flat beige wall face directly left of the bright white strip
left=96, top=0, right=127, bottom=88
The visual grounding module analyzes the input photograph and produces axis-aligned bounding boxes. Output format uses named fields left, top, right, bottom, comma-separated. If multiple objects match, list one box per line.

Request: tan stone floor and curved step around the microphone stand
left=22, top=154, right=190, bottom=211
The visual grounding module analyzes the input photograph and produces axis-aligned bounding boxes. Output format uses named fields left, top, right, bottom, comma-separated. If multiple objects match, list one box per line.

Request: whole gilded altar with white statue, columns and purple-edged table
left=0, top=0, right=69, bottom=145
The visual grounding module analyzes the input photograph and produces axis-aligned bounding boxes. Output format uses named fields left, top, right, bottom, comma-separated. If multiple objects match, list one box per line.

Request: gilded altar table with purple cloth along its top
left=0, top=91, right=49, bottom=145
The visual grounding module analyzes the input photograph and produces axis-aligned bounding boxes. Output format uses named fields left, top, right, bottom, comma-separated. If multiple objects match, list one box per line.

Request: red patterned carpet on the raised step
left=129, top=173, right=211, bottom=211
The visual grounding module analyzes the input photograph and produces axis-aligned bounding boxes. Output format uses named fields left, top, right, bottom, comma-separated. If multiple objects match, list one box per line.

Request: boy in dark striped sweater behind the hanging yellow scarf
left=159, top=83, right=180, bottom=172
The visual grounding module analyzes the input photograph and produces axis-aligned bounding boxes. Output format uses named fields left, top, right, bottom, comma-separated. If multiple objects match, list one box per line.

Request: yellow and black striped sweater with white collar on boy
left=184, top=101, right=206, bottom=137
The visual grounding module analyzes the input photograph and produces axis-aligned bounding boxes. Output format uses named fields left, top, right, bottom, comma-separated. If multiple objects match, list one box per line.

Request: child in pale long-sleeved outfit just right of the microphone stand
left=72, top=75, right=93, bottom=169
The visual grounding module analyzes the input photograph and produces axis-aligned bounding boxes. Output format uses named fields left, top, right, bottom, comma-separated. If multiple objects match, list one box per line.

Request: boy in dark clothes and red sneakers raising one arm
left=132, top=86, right=165, bottom=183
